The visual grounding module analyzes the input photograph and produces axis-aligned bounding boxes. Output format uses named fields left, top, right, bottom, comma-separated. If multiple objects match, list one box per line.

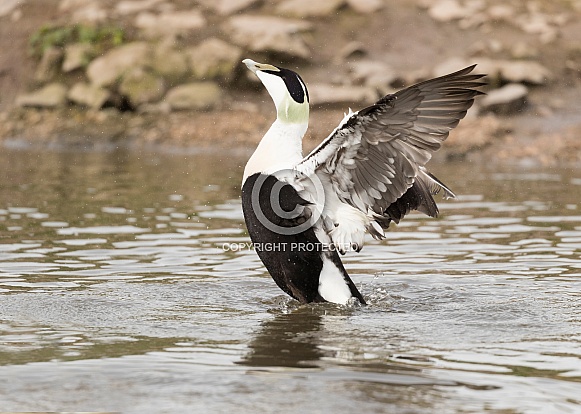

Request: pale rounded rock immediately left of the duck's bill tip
left=188, top=38, right=242, bottom=81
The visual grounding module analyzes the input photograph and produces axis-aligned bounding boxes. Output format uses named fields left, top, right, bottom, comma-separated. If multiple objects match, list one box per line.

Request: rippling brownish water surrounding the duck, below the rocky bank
left=0, top=149, right=581, bottom=413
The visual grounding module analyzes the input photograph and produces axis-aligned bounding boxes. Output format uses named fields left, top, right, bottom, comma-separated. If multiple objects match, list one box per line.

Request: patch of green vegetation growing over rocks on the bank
left=28, top=24, right=125, bottom=58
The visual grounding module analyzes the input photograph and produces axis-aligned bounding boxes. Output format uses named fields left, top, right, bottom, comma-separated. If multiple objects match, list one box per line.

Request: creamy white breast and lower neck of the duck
left=243, top=118, right=308, bottom=181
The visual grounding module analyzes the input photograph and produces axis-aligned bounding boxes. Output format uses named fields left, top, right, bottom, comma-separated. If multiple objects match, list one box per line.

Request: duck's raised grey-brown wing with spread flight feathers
left=296, top=65, right=484, bottom=226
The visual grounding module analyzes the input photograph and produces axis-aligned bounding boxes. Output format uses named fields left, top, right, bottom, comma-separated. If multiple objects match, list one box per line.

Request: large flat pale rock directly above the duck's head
left=223, top=15, right=312, bottom=59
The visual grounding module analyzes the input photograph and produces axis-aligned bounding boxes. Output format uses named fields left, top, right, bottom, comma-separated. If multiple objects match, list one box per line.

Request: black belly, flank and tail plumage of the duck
left=242, top=173, right=365, bottom=304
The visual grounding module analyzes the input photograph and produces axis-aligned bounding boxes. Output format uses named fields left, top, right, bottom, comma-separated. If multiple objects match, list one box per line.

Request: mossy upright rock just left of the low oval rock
left=119, top=67, right=165, bottom=107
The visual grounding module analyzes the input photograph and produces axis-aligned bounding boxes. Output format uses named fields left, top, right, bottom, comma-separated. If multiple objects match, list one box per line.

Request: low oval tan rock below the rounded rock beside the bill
left=165, top=82, right=222, bottom=110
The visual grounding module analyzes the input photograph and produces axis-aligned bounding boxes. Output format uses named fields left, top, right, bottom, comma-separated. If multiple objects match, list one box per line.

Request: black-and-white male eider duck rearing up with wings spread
left=242, top=59, right=484, bottom=304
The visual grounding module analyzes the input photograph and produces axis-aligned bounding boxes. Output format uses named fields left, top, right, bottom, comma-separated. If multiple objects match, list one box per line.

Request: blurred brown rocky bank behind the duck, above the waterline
left=0, top=0, right=581, bottom=166
